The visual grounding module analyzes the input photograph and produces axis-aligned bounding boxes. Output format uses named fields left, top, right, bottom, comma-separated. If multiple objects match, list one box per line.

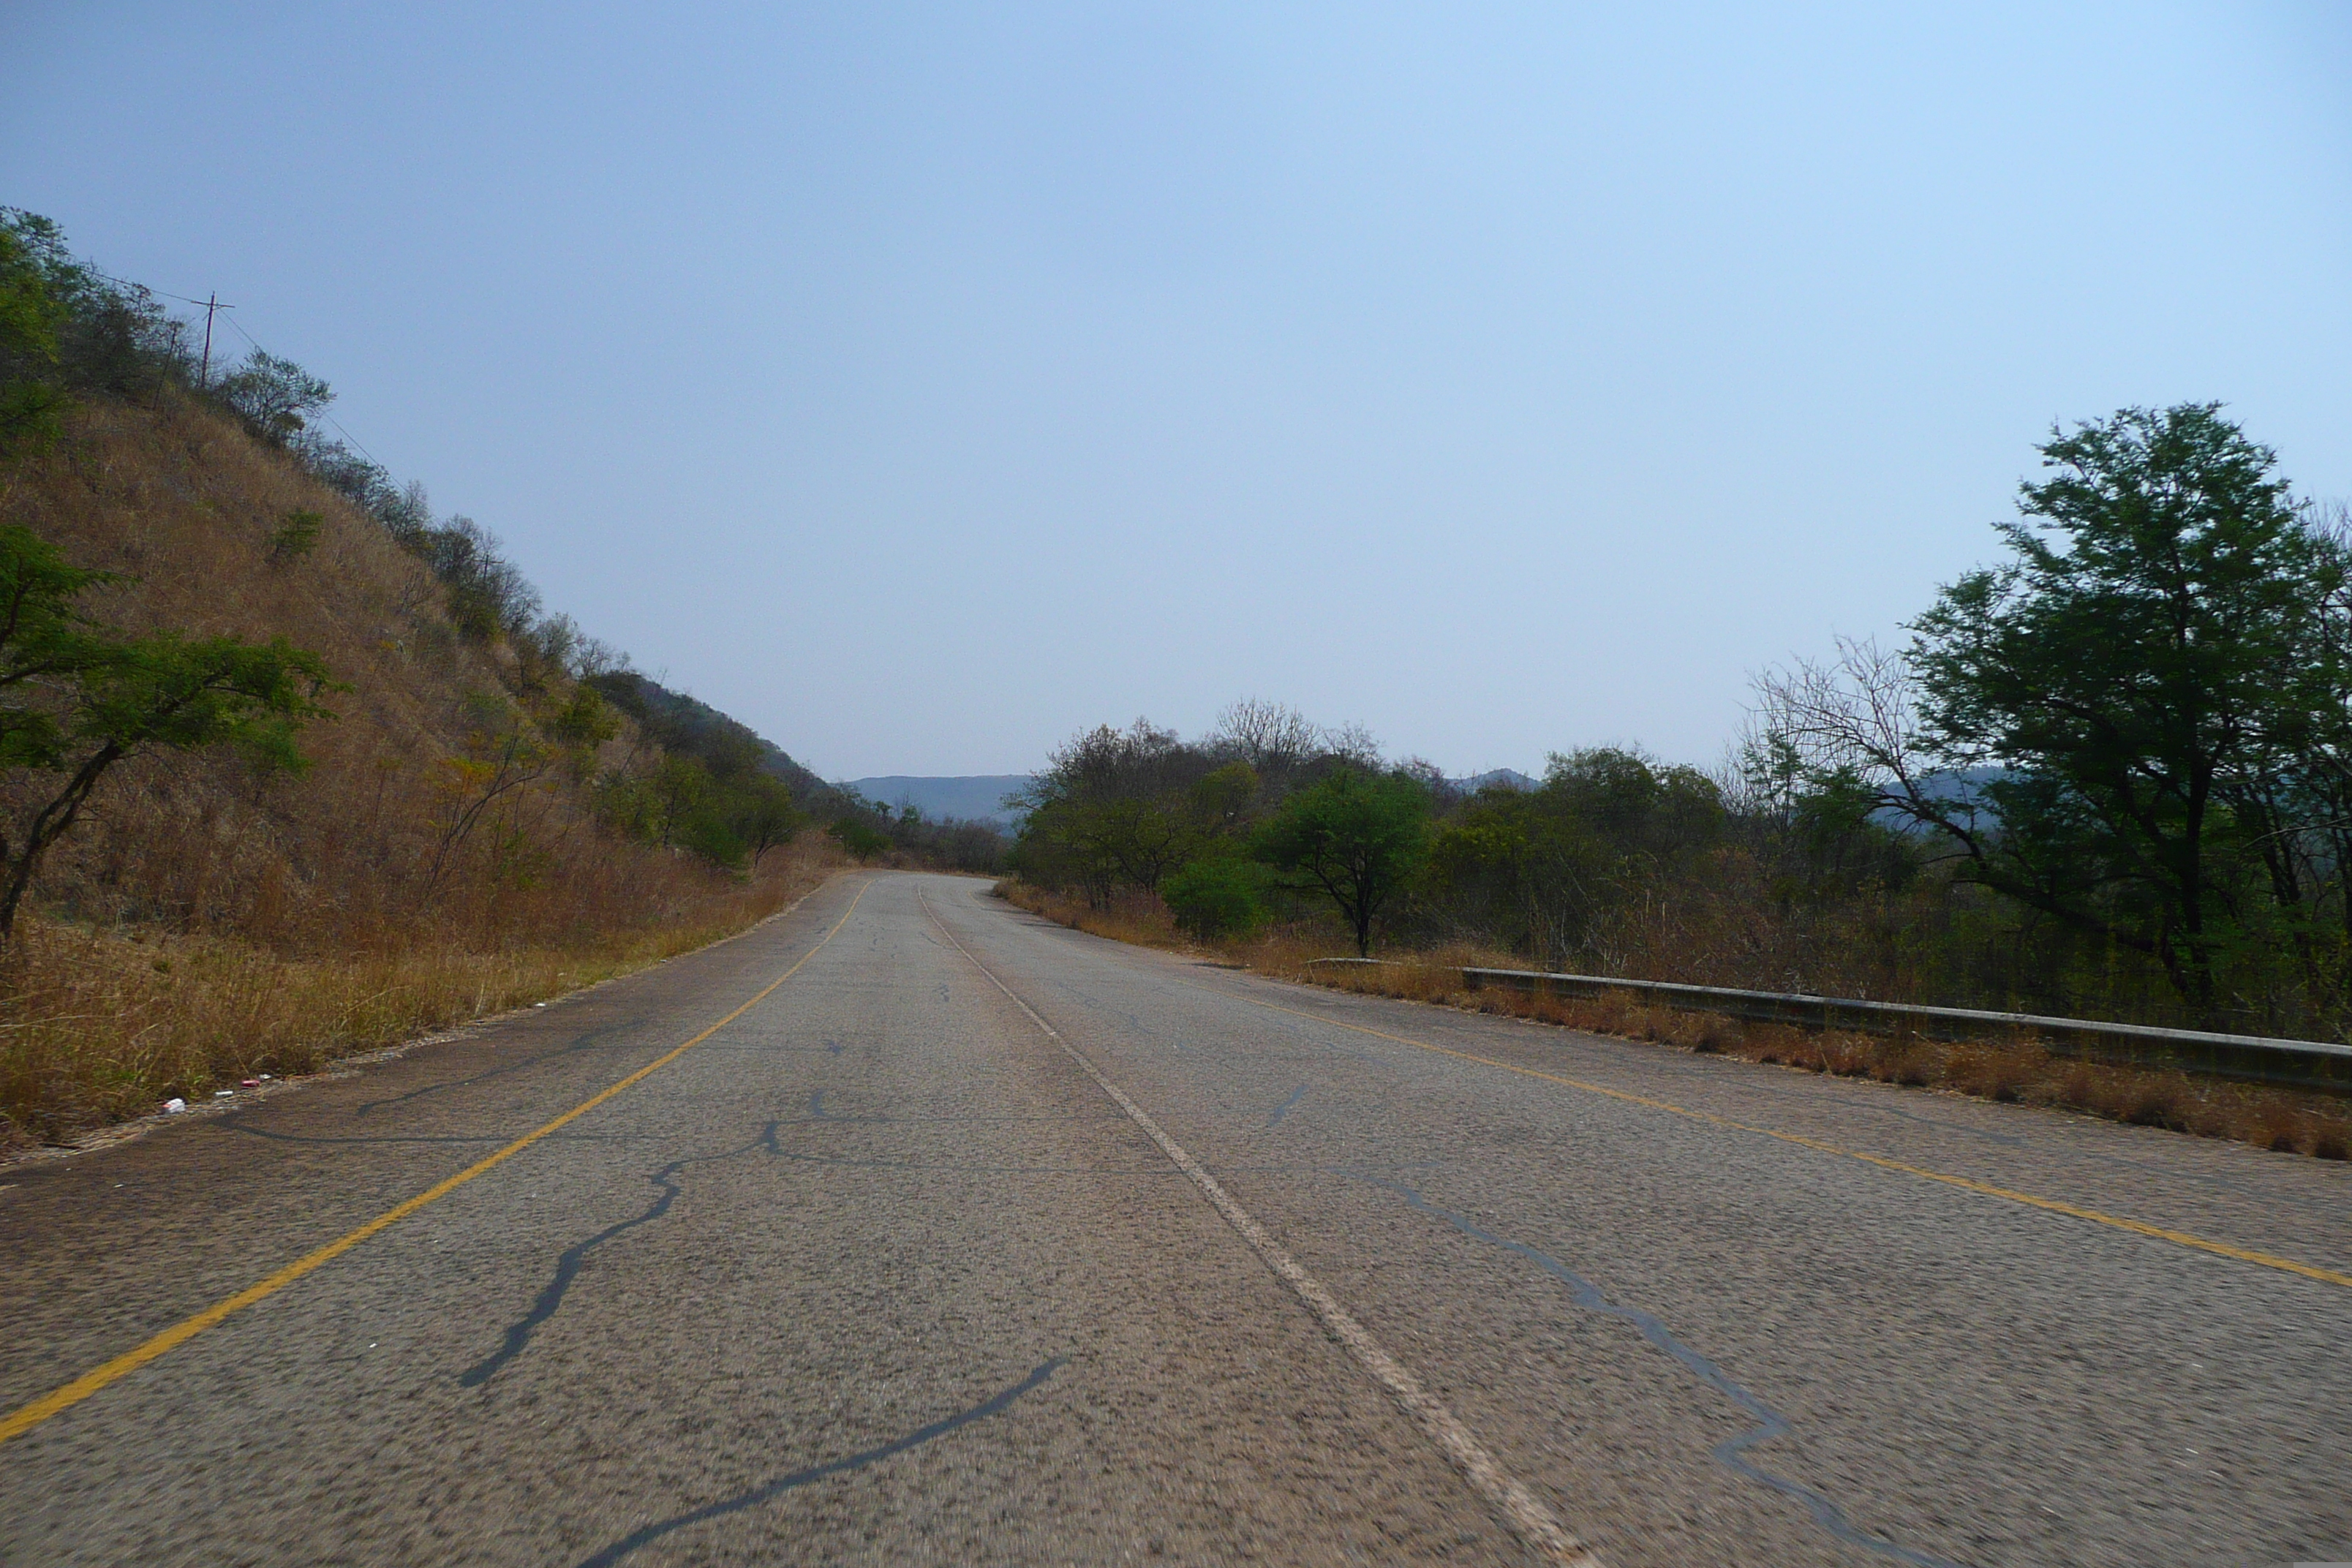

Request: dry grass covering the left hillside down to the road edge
left=0, top=395, right=845, bottom=1150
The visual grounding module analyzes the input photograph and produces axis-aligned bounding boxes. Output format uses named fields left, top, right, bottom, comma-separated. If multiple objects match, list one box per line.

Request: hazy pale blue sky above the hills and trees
left=0, top=0, right=2352, bottom=776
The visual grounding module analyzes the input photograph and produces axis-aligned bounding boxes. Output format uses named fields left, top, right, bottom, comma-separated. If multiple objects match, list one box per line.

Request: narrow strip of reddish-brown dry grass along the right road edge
left=998, top=879, right=2352, bottom=1159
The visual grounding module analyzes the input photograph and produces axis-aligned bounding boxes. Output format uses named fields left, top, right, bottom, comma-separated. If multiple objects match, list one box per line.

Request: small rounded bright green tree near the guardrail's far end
left=1249, top=766, right=1433, bottom=957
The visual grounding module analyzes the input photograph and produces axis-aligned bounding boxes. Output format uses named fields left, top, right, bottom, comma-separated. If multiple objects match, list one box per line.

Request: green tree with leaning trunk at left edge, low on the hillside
left=0, top=527, right=344, bottom=941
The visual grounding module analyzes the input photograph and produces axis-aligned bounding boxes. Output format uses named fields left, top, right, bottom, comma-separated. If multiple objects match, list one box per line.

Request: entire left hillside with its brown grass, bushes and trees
left=0, top=211, right=992, bottom=1147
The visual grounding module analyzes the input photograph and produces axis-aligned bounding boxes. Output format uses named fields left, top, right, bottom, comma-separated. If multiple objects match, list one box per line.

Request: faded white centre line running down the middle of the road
left=917, top=893, right=1602, bottom=1568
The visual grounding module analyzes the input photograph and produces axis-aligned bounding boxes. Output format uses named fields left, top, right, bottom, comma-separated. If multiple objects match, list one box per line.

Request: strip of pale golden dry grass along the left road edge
left=0, top=834, right=842, bottom=1152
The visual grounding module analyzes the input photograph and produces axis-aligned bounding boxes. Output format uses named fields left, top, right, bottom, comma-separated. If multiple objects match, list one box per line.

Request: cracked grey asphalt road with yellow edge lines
left=0, top=875, right=2352, bottom=1568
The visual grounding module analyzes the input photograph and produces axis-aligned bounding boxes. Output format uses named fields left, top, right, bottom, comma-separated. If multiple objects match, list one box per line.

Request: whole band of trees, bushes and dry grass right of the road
left=1006, top=404, right=2352, bottom=1154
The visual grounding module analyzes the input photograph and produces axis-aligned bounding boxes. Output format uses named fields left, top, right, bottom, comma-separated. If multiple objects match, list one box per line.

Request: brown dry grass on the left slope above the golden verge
left=0, top=402, right=672, bottom=954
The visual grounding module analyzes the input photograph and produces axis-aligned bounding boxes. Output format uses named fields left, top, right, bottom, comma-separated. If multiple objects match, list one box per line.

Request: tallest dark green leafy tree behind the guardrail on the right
left=1910, top=404, right=2345, bottom=1011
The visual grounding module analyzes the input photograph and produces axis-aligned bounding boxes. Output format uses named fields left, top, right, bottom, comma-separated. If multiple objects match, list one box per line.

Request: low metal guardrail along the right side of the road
left=1324, top=959, right=2352, bottom=1093
